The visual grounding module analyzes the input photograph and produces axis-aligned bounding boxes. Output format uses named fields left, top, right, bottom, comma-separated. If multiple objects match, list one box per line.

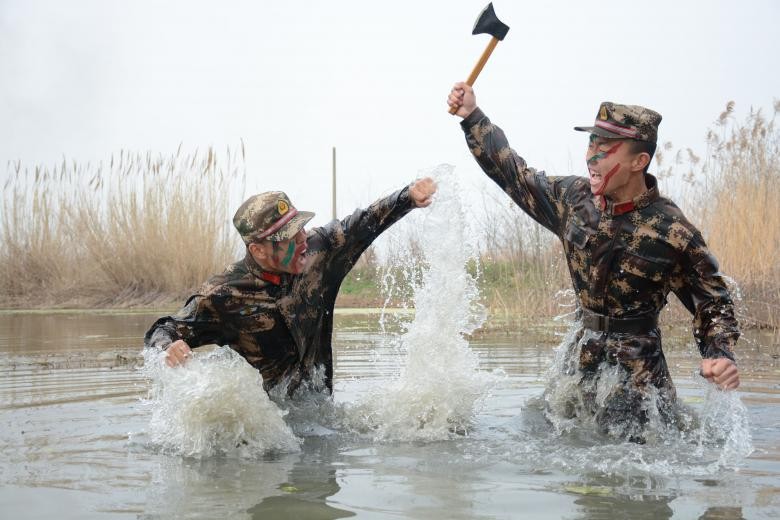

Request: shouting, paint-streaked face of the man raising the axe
left=585, top=134, right=630, bottom=197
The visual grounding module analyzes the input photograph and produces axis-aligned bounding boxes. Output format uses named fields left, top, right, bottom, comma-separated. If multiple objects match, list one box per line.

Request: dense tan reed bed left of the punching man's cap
left=0, top=145, right=244, bottom=307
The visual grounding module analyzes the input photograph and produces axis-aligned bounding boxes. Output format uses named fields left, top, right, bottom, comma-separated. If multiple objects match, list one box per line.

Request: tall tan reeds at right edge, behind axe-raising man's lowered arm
left=660, top=101, right=780, bottom=328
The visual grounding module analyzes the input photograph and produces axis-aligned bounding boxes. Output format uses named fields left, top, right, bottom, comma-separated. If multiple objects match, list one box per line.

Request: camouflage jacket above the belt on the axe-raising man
left=461, top=108, right=739, bottom=359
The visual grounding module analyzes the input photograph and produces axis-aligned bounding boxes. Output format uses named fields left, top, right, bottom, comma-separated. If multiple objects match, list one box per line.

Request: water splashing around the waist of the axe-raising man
left=528, top=308, right=753, bottom=477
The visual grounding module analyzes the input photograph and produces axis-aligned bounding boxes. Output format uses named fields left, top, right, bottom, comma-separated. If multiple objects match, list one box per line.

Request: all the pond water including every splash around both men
left=0, top=169, right=780, bottom=519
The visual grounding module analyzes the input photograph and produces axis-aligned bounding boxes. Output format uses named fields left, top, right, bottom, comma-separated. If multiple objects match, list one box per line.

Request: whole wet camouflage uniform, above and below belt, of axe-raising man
left=461, top=108, right=739, bottom=434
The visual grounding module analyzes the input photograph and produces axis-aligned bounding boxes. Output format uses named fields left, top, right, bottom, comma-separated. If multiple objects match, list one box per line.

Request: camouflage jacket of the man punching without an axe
left=144, top=188, right=413, bottom=393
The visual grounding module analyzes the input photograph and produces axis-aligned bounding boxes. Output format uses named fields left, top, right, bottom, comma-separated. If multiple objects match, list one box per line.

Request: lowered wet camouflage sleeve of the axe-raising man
left=674, top=232, right=740, bottom=361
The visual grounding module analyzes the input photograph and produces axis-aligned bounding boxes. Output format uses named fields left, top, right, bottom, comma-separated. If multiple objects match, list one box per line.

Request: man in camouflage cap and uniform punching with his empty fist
left=144, top=178, right=436, bottom=394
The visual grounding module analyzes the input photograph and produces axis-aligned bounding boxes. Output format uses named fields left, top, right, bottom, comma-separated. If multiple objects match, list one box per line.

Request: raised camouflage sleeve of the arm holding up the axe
left=460, top=108, right=573, bottom=235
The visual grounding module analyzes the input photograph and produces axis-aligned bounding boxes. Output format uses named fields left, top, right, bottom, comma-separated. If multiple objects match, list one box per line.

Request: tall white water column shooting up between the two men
left=349, top=165, right=495, bottom=441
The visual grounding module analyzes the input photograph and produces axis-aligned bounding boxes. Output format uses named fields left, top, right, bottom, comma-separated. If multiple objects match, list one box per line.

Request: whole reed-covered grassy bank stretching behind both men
left=0, top=104, right=780, bottom=328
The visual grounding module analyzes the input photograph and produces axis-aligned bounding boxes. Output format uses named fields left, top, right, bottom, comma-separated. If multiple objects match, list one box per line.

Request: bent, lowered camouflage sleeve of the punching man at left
left=144, top=295, right=236, bottom=350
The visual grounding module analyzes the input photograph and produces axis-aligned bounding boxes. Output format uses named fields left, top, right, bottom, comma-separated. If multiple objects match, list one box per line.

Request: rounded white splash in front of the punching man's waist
left=143, top=347, right=300, bottom=458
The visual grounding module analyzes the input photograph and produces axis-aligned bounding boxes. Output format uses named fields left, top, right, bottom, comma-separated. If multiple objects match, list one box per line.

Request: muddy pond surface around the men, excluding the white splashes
left=0, top=313, right=780, bottom=519
